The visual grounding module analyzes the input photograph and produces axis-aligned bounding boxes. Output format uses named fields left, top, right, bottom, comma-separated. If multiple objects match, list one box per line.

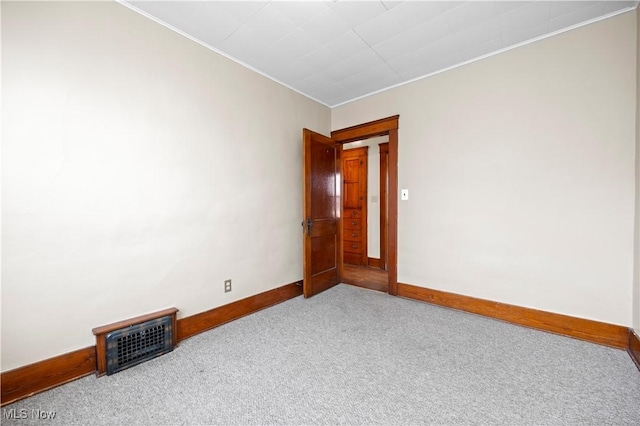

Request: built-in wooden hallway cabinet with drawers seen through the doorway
left=342, top=146, right=369, bottom=266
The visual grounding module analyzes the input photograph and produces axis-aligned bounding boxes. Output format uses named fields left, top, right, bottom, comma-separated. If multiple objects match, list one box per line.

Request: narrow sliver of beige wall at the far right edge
left=633, top=7, right=640, bottom=332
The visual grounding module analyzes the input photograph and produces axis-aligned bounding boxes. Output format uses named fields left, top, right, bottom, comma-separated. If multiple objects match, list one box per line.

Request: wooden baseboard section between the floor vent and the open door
left=178, top=281, right=302, bottom=341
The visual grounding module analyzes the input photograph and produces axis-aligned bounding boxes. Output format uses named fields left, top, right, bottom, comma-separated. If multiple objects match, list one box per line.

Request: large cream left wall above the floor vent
left=2, top=2, right=330, bottom=371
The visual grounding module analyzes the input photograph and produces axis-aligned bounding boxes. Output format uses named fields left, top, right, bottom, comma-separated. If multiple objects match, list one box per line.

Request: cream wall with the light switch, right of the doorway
left=331, top=12, right=636, bottom=326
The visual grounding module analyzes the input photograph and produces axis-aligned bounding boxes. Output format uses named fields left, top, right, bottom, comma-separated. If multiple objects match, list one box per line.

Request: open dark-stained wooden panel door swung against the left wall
left=302, top=129, right=342, bottom=297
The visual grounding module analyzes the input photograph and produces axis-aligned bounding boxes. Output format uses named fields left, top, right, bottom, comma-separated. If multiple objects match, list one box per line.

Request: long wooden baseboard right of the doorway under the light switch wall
left=398, top=283, right=629, bottom=349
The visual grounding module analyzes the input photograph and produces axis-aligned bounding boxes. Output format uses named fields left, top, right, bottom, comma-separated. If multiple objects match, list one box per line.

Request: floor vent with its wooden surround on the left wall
left=93, top=308, right=177, bottom=375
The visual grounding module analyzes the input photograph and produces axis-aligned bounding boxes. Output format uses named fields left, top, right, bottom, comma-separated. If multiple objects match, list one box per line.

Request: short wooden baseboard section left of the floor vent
left=0, top=346, right=96, bottom=405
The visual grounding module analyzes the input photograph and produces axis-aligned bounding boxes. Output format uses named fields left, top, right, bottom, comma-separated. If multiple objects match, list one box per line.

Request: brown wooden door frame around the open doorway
left=331, top=115, right=400, bottom=296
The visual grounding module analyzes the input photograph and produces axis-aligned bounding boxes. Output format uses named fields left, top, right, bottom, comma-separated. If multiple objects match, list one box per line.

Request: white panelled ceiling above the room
left=121, top=0, right=638, bottom=107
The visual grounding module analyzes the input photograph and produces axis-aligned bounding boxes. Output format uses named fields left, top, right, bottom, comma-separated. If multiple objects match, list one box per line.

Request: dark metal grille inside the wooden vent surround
left=106, top=316, right=173, bottom=375
